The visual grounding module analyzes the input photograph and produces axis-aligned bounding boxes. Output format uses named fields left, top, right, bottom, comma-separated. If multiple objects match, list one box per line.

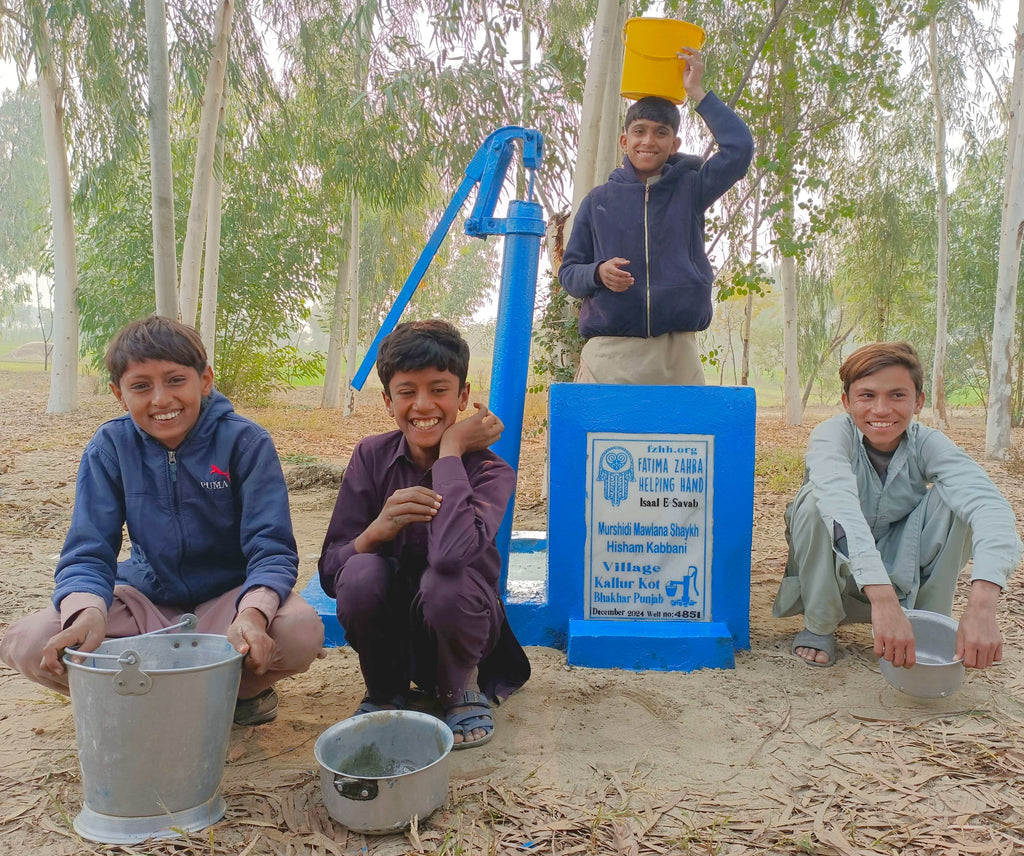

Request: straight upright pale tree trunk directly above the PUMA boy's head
left=145, top=0, right=178, bottom=318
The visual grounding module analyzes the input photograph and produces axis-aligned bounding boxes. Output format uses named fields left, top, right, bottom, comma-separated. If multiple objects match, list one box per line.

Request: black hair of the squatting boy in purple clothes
left=377, top=318, right=469, bottom=397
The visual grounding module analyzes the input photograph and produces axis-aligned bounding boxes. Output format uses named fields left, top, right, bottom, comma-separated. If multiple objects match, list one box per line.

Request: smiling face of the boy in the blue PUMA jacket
left=111, top=359, right=213, bottom=450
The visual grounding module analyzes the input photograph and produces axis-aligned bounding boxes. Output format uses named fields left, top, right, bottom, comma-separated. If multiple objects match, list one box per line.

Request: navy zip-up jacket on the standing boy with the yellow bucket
left=558, top=92, right=754, bottom=339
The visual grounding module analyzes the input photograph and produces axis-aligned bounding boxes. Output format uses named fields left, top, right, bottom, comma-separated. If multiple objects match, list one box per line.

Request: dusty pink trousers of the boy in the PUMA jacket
left=0, top=586, right=324, bottom=698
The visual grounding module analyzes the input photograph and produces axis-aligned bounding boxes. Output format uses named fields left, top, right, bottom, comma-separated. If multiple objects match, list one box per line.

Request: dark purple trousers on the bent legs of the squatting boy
left=335, top=553, right=503, bottom=704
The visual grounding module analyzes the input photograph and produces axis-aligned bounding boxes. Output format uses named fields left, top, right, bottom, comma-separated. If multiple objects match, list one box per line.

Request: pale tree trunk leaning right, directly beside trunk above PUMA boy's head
left=178, top=0, right=234, bottom=325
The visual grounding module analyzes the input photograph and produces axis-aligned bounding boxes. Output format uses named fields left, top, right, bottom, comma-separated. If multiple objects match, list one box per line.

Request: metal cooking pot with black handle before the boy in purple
left=313, top=711, right=455, bottom=834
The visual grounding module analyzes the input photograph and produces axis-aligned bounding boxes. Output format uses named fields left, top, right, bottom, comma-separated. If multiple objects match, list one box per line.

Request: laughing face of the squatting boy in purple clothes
left=384, top=367, right=469, bottom=469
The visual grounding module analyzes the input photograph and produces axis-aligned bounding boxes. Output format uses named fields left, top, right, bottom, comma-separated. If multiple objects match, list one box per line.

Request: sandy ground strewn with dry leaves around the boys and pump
left=0, top=372, right=1024, bottom=856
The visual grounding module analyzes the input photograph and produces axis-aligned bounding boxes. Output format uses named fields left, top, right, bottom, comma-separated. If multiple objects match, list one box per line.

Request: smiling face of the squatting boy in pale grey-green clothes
left=843, top=366, right=925, bottom=452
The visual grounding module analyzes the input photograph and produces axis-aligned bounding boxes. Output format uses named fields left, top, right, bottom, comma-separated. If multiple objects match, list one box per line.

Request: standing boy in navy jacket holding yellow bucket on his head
left=558, top=48, right=754, bottom=385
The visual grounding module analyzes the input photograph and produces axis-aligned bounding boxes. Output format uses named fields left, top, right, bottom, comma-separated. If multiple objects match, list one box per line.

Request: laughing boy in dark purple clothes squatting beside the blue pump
left=319, top=320, right=529, bottom=748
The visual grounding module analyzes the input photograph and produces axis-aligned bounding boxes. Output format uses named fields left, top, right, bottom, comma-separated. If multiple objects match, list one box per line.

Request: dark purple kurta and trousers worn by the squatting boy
left=318, top=431, right=529, bottom=703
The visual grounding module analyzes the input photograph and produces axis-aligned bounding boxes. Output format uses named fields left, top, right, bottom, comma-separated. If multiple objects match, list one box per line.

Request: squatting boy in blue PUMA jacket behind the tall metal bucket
left=0, top=315, right=324, bottom=725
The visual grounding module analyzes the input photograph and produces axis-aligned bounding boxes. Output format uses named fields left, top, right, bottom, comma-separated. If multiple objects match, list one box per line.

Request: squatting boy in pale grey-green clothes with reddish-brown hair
left=772, top=342, right=1021, bottom=669
